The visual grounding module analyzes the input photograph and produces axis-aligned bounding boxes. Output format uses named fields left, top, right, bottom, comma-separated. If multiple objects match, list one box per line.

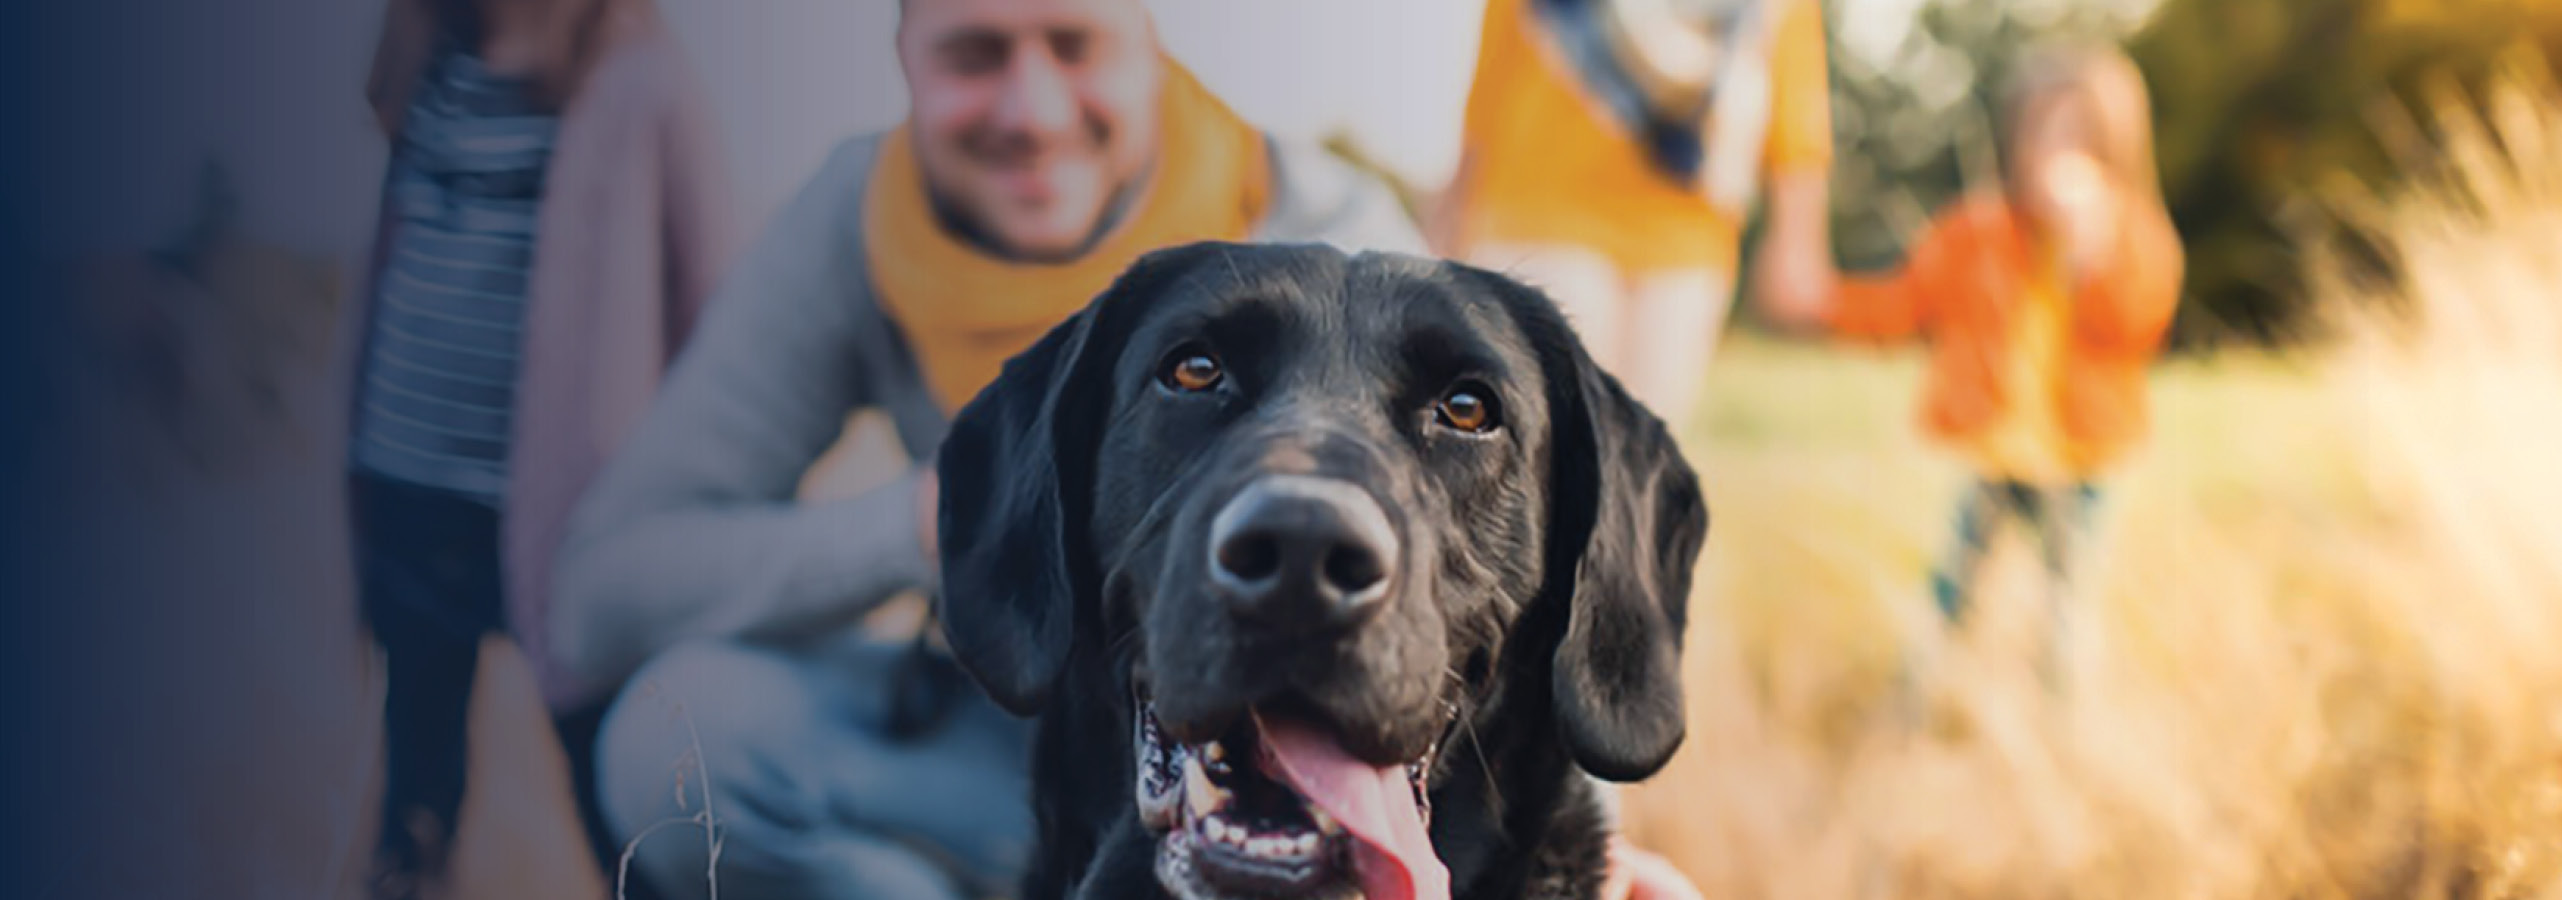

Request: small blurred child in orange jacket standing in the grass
left=1778, top=49, right=2183, bottom=677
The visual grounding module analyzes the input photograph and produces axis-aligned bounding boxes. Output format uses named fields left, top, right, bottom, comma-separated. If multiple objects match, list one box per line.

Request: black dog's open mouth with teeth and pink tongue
left=1132, top=703, right=1450, bottom=900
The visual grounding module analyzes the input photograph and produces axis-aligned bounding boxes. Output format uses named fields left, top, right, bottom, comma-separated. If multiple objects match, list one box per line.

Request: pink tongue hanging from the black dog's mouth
left=1255, top=715, right=1450, bottom=900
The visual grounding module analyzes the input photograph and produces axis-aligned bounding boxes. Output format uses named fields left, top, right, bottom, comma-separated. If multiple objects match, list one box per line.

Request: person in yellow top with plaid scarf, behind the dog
left=1432, top=0, right=1834, bottom=426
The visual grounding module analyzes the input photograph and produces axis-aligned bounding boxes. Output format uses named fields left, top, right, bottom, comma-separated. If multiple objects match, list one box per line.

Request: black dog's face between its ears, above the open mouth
left=1089, top=244, right=1547, bottom=764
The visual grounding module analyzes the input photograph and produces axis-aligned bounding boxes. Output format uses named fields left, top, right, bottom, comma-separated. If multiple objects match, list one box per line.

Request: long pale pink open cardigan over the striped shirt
left=341, top=3, right=735, bottom=710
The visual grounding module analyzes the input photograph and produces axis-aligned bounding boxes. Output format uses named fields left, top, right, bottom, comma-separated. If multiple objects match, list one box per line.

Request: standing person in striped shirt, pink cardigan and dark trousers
left=346, top=0, right=730, bottom=897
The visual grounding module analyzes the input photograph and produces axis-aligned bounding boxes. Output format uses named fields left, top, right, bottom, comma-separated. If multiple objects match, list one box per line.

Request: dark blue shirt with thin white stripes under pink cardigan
left=351, top=51, right=559, bottom=505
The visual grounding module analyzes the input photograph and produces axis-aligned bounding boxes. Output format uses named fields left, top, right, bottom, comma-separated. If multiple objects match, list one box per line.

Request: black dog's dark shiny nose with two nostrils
left=1209, top=474, right=1396, bottom=633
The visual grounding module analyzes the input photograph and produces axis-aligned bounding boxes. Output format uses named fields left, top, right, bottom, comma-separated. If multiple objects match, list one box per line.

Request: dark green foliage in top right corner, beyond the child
left=2129, top=0, right=2554, bottom=338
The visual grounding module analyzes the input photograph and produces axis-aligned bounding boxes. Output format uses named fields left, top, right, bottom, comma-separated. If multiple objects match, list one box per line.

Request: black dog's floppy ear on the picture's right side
left=1478, top=262, right=1709, bottom=782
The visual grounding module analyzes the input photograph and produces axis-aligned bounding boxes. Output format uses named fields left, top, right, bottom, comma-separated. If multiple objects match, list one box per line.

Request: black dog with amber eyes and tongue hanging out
left=938, top=244, right=1706, bottom=900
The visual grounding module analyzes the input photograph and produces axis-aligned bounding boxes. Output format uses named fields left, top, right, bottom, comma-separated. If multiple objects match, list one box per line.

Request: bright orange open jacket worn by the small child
left=1829, top=197, right=2183, bottom=467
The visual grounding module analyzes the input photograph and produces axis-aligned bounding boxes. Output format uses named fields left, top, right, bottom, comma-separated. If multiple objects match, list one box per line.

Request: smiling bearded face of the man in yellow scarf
left=899, top=0, right=1163, bottom=259
